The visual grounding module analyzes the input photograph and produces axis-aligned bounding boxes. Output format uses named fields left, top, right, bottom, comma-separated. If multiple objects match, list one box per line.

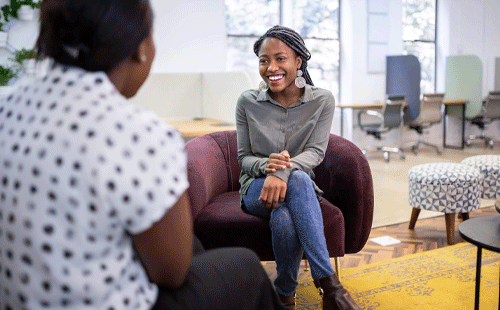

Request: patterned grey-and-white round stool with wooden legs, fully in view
left=408, top=163, right=483, bottom=244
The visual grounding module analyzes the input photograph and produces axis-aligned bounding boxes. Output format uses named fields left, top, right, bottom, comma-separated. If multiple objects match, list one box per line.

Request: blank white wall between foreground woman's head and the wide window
left=150, top=0, right=226, bottom=73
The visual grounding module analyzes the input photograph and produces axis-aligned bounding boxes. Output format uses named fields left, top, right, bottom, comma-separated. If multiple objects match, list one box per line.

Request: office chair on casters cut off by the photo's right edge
left=465, top=91, right=500, bottom=148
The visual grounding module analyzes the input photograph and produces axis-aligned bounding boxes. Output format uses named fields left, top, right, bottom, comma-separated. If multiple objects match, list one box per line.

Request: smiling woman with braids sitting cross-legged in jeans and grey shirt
left=236, top=26, right=360, bottom=309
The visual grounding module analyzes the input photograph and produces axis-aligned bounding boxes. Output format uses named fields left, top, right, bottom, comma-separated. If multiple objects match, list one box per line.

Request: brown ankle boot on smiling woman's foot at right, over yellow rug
left=314, top=273, right=362, bottom=310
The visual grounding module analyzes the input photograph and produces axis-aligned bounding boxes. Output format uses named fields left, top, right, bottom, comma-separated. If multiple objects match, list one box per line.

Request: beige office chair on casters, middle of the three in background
left=406, top=94, right=444, bottom=155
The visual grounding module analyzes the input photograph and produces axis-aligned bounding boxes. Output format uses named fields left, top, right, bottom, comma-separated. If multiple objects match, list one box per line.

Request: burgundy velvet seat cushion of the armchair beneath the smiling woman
left=194, top=191, right=345, bottom=260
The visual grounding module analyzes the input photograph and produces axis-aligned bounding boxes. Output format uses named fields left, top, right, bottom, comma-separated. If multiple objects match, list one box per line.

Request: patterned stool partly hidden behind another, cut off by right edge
left=462, top=155, right=500, bottom=199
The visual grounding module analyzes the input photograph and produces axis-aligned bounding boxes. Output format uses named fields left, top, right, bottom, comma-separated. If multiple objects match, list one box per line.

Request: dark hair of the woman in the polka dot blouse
left=36, top=0, right=153, bottom=72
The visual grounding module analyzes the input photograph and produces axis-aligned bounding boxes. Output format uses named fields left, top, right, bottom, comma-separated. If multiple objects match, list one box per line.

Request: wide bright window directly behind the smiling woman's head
left=225, top=0, right=340, bottom=99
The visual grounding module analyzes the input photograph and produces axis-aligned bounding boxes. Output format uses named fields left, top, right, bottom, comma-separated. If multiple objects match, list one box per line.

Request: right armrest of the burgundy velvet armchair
left=314, top=134, right=374, bottom=253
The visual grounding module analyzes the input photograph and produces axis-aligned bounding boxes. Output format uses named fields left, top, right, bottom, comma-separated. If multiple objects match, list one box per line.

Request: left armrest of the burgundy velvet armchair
left=185, top=135, right=228, bottom=220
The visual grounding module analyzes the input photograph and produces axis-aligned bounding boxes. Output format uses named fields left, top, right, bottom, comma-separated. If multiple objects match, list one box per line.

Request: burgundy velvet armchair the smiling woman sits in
left=186, top=131, right=373, bottom=272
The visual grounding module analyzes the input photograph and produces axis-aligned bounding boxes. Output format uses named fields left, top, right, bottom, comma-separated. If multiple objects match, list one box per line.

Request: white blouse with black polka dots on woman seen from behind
left=0, top=66, right=188, bottom=310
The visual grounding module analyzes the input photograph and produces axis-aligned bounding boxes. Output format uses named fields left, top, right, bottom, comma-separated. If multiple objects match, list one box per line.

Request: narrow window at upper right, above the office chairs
left=403, top=0, right=437, bottom=94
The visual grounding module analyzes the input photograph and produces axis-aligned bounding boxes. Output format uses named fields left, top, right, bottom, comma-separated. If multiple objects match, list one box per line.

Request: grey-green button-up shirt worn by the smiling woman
left=236, top=85, right=335, bottom=194
